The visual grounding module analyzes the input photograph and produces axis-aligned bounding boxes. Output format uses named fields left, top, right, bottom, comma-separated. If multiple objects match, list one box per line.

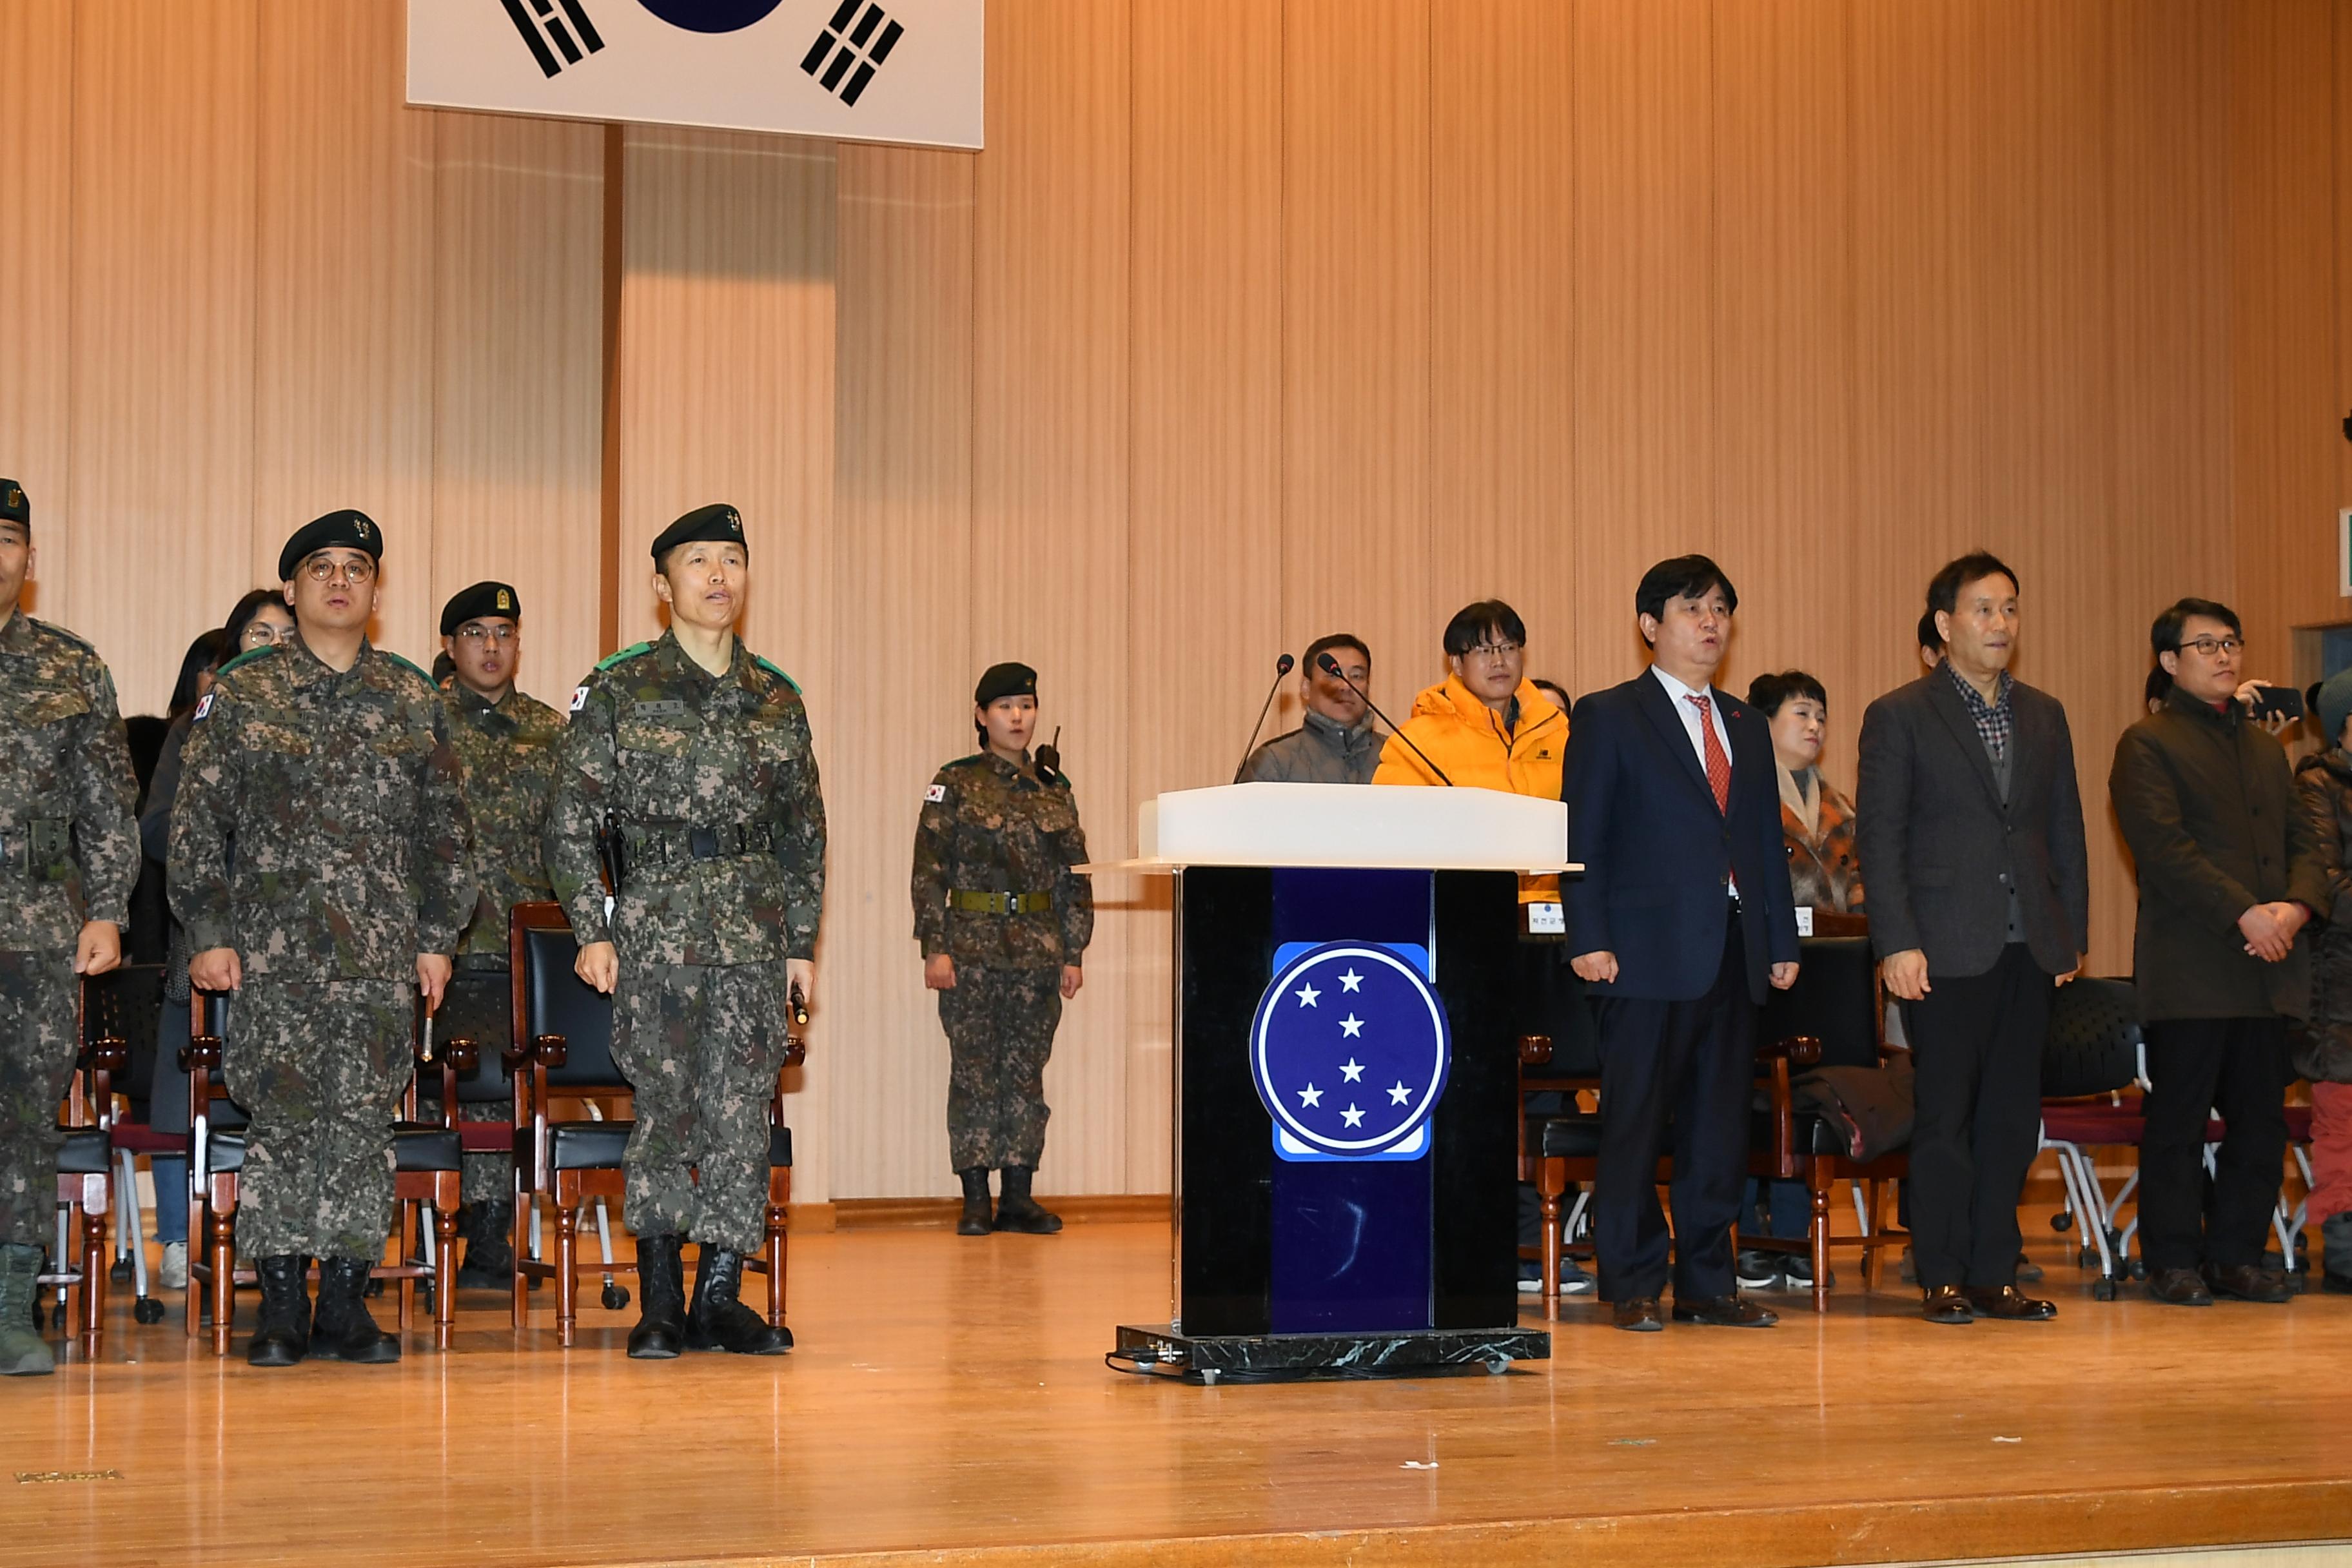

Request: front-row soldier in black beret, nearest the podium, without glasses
left=545, top=505, right=825, bottom=1361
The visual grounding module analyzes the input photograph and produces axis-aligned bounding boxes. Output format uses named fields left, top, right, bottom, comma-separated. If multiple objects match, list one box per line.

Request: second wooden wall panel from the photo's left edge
left=66, top=0, right=257, bottom=712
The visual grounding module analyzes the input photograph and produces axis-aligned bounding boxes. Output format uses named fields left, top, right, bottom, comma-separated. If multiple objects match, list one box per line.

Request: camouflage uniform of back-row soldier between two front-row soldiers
left=433, top=681, right=565, bottom=1204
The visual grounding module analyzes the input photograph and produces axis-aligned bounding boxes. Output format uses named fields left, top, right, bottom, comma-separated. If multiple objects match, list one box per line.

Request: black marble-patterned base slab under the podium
left=1108, top=1324, right=1553, bottom=1382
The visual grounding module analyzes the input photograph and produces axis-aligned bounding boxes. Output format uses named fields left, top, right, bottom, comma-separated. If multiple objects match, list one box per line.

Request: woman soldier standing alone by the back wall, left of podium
left=915, top=665, right=1093, bottom=1237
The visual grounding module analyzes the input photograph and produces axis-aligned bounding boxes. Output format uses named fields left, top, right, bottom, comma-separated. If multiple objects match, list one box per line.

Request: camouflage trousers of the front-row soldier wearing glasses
left=221, top=980, right=416, bottom=1262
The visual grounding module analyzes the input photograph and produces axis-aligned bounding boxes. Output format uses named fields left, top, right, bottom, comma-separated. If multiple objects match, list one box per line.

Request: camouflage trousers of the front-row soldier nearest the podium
left=611, top=959, right=785, bottom=1253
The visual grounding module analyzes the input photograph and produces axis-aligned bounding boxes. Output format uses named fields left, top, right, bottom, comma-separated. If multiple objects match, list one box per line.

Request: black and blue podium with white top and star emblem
left=1089, top=783, right=1574, bottom=1382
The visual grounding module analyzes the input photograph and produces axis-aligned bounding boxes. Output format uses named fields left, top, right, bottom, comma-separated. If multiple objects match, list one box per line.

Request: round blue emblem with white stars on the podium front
left=1249, top=943, right=1453, bottom=1159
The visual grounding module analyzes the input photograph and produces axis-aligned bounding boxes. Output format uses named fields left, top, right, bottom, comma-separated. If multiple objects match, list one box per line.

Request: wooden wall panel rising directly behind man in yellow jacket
left=1397, top=0, right=1590, bottom=694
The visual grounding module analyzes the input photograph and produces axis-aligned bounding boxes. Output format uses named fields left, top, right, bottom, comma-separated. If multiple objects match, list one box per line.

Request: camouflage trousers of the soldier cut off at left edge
left=0, top=952, right=80, bottom=1248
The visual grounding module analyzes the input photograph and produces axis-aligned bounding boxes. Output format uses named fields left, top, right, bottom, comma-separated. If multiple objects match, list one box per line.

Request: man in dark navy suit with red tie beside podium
left=1560, top=554, right=1797, bottom=1331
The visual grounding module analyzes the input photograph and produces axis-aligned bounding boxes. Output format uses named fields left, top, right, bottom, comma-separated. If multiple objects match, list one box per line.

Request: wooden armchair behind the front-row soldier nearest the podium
left=508, top=903, right=807, bottom=1345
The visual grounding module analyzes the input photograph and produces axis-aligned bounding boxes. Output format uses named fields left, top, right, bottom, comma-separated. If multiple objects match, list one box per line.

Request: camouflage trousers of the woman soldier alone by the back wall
left=939, top=964, right=1061, bottom=1171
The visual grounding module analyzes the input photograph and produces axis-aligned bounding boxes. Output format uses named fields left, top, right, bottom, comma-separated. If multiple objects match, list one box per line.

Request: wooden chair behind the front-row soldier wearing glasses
left=183, top=990, right=480, bottom=1357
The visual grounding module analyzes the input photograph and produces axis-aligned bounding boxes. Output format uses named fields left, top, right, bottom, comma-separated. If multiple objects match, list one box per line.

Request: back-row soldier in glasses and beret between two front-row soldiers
left=435, top=583, right=565, bottom=1286
